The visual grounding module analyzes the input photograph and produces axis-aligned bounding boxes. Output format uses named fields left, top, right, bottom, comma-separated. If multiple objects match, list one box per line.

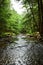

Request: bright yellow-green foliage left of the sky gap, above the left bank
left=0, top=0, right=21, bottom=34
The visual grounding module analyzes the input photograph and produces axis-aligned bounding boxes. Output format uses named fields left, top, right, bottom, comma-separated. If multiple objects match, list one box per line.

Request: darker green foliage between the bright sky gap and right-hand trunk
left=18, top=0, right=39, bottom=34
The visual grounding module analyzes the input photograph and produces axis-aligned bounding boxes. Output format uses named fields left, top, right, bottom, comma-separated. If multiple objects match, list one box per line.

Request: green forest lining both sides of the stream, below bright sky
left=0, top=0, right=43, bottom=37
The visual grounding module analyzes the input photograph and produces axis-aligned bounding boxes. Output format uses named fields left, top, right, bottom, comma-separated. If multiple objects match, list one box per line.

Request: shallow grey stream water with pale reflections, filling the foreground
left=0, top=34, right=43, bottom=65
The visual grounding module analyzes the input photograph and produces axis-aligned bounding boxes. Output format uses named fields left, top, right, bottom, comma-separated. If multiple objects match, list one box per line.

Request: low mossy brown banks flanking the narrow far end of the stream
left=0, top=33, right=42, bottom=44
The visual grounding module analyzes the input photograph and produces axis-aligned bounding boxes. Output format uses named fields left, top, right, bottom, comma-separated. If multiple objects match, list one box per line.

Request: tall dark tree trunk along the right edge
left=38, top=0, right=43, bottom=38
